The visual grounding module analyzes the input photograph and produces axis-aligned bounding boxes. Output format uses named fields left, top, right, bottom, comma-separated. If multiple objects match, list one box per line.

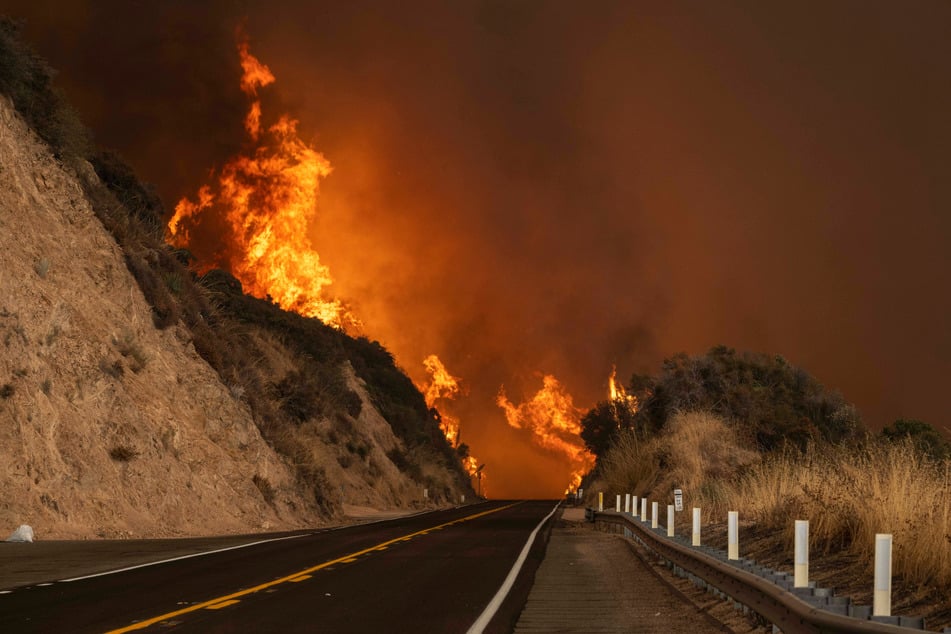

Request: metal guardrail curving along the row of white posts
left=585, top=508, right=921, bottom=634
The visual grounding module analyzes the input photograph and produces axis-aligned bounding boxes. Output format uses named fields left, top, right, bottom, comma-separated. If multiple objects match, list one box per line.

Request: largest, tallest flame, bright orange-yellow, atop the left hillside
left=168, top=34, right=358, bottom=327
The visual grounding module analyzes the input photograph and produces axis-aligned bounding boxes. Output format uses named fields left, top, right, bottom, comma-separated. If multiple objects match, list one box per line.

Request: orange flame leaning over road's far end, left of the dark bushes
left=496, top=374, right=594, bottom=491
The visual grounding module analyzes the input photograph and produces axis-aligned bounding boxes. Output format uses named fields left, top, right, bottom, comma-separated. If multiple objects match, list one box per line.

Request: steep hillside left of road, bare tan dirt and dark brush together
left=0, top=19, right=473, bottom=538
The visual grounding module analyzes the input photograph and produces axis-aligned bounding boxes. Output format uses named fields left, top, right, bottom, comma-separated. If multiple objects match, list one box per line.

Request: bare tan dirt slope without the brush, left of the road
left=0, top=97, right=324, bottom=538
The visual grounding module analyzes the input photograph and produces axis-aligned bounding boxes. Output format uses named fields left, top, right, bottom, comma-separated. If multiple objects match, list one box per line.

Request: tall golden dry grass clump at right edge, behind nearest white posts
left=727, top=441, right=951, bottom=585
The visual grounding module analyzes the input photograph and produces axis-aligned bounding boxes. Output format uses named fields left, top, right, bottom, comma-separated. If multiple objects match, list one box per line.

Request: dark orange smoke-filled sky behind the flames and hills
left=4, top=0, right=951, bottom=497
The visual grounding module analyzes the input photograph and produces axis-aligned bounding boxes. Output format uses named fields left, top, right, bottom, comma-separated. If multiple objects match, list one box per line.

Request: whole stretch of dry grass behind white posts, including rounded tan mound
left=588, top=413, right=951, bottom=596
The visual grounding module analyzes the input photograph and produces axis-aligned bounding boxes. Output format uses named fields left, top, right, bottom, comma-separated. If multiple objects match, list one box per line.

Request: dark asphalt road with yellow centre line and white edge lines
left=0, top=501, right=555, bottom=632
